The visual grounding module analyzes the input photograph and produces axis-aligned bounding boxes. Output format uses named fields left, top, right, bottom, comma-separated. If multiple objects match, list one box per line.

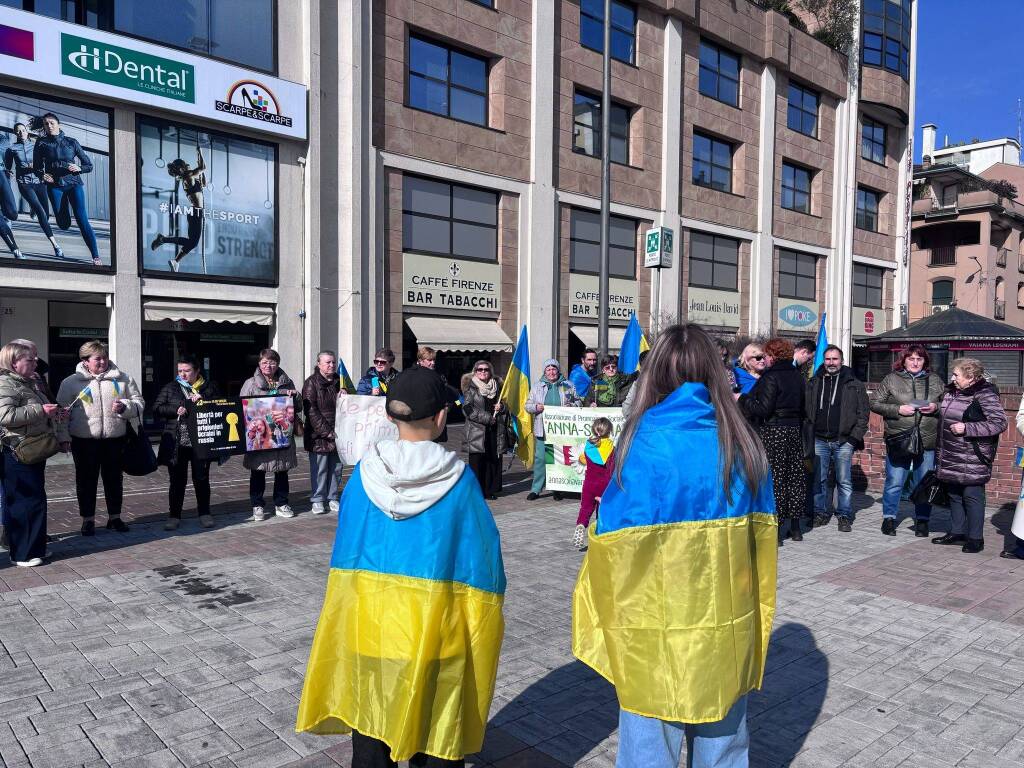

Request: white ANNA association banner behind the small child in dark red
left=544, top=406, right=626, bottom=494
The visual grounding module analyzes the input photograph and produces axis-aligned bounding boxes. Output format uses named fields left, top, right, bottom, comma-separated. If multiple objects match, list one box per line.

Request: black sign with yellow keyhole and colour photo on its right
left=188, top=396, right=295, bottom=459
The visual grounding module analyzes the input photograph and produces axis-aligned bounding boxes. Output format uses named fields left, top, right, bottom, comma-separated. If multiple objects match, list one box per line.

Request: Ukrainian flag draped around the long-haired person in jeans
left=572, top=384, right=778, bottom=723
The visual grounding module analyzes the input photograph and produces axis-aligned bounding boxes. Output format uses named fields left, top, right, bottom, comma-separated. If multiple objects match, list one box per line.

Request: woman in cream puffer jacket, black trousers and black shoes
left=57, top=341, right=145, bottom=536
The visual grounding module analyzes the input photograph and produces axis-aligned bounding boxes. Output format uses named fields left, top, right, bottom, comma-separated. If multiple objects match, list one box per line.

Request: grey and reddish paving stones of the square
left=0, top=450, right=1024, bottom=768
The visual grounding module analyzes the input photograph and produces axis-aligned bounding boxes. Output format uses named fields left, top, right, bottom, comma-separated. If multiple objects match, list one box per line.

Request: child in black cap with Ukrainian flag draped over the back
left=295, top=367, right=505, bottom=768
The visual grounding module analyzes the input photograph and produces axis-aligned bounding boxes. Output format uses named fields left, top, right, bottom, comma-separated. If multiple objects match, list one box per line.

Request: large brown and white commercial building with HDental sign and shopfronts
left=0, top=0, right=916, bottom=411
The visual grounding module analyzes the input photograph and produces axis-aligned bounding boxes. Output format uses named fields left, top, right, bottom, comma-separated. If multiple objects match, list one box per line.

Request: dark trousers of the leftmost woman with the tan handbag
left=0, top=449, right=46, bottom=562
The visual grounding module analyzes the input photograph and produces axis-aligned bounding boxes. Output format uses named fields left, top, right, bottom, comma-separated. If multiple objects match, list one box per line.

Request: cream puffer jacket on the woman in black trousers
left=57, top=360, right=145, bottom=442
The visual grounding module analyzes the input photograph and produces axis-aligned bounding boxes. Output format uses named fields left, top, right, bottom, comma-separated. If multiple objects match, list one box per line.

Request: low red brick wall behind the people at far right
left=853, top=385, right=1024, bottom=507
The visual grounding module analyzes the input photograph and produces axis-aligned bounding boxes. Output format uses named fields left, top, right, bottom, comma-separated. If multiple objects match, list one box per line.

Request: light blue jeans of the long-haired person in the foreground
left=615, top=696, right=751, bottom=768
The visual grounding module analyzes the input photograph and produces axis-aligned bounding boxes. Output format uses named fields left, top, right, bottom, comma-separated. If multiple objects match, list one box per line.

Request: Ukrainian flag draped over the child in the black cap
left=295, top=465, right=505, bottom=761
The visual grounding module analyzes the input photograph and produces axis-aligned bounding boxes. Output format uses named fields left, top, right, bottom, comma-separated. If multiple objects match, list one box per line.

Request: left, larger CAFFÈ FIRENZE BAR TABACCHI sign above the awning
left=401, top=253, right=502, bottom=312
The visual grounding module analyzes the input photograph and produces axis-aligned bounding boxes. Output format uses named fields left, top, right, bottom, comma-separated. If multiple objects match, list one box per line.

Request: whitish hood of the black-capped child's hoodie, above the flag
left=359, top=440, right=466, bottom=520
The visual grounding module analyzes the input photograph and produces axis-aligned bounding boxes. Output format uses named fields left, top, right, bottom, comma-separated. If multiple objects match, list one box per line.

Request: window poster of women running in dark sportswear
left=0, top=88, right=113, bottom=270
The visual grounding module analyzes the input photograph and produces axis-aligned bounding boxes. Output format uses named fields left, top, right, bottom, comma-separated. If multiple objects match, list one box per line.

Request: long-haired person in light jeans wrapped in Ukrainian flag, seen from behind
left=572, top=325, right=777, bottom=768
